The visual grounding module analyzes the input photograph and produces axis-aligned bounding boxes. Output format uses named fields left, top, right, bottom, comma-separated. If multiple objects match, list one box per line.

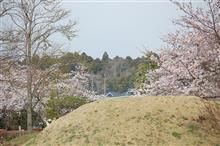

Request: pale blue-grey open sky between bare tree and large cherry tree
left=58, top=0, right=201, bottom=58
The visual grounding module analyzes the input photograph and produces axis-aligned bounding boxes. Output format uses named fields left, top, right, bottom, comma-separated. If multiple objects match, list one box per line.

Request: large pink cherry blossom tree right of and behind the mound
left=145, top=0, right=220, bottom=97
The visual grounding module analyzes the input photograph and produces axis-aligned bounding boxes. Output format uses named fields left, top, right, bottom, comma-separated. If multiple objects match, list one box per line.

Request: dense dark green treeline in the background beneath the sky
left=20, top=52, right=153, bottom=94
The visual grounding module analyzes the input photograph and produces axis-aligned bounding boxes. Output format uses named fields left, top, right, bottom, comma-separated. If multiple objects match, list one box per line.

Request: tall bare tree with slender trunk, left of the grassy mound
left=1, top=0, right=75, bottom=132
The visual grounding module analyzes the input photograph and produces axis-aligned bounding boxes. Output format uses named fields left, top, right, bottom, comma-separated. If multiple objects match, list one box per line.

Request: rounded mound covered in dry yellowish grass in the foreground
left=27, top=97, right=220, bottom=146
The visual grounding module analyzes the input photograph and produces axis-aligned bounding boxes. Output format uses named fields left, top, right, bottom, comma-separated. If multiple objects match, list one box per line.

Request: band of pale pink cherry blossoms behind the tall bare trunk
left=0, top=63, right=104, bottom=111
